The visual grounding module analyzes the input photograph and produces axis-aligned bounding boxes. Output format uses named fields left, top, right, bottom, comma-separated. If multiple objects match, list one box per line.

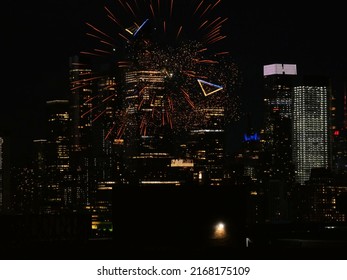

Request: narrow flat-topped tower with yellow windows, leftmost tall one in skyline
left=42, top=100, right=71, bottom=213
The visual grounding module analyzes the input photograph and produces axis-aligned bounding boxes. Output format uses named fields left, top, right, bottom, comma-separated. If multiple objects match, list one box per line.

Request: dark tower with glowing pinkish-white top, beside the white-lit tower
left=261, top=64, right=297, bottom=184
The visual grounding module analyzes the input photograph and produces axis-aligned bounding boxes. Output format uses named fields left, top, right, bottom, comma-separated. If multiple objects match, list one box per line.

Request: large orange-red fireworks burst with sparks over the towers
left=73, top=0, right=242, bottom=139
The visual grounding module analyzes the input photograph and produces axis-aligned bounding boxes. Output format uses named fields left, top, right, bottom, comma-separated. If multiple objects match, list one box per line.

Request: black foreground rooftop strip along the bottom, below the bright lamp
left=0, top=225, right=347, bottom=260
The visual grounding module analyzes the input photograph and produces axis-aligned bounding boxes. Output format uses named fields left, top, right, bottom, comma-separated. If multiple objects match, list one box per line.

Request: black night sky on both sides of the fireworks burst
left=0, top=0, right=347, bottom=164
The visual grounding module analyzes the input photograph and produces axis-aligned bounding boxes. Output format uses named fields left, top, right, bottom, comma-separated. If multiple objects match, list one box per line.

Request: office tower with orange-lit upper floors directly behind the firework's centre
left=122, top=70, right=178, bottom=186
